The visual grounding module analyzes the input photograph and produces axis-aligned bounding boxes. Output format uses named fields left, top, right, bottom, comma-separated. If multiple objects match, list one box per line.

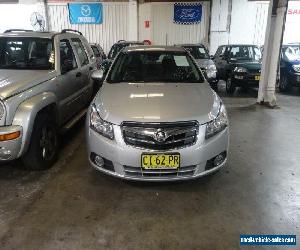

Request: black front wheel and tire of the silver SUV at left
left=22, top=113, right=59, bottom=170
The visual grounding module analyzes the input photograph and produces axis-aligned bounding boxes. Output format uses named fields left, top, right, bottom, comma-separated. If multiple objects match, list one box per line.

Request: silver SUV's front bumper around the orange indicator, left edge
left=0, top=125, right=22, bottom=162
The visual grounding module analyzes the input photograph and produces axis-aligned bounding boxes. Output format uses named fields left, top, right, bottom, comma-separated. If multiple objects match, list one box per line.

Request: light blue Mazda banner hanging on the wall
left=68, top=3, right=103, bottom=24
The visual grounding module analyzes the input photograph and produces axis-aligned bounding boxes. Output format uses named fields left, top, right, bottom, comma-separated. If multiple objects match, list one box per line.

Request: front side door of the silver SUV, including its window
left=57, top=39, right=81, bottom=123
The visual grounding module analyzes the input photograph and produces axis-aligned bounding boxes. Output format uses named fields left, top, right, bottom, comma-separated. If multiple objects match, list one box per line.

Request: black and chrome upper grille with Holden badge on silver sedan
left=122, top=122, right=199, bottom=150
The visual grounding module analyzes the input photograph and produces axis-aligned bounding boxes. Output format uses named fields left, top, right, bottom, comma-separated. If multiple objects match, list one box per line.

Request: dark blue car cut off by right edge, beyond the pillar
left=279, top=44, right=300, bottom=92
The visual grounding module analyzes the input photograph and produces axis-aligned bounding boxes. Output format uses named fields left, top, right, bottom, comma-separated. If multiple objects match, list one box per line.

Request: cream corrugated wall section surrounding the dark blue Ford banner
left=139, top=2, right=210, bottom=45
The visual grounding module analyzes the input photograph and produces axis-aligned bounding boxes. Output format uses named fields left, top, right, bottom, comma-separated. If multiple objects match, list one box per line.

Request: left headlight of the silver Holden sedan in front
left=90, top=104, right=114, bottom=140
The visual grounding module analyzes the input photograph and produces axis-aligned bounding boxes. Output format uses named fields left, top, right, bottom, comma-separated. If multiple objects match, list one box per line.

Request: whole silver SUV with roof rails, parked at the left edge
left=0, top=30, right=96, bottom=169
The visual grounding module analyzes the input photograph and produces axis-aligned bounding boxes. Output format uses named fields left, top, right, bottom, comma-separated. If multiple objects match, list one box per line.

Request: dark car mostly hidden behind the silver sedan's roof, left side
left=101, top=40, right=144, bottom=75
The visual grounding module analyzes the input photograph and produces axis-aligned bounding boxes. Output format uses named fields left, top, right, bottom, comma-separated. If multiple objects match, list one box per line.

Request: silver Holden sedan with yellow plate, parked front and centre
left=86, top=46, right=229, bottom=181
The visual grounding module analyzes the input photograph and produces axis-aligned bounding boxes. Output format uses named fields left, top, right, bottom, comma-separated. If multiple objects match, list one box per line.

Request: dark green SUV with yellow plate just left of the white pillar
left=214, top=45, right=261, bottom=94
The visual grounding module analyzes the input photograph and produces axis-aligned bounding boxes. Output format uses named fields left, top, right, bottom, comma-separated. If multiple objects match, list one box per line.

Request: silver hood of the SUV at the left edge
left=0, top=69, right=56, bottom=100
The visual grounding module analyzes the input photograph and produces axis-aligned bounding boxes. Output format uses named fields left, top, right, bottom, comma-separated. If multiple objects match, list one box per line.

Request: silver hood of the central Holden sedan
left=94, top=83, right=218, bottom=125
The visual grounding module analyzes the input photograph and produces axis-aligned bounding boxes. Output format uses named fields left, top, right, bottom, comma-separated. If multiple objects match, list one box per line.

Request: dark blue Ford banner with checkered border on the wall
left=174, top=3, right=202, bottom=24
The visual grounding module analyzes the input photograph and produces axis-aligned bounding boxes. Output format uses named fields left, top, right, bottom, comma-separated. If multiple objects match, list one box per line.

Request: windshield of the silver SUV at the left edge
left=0, top=37, right=54, bottom=70
